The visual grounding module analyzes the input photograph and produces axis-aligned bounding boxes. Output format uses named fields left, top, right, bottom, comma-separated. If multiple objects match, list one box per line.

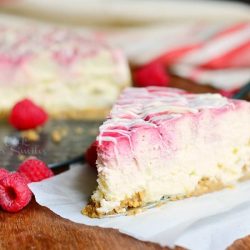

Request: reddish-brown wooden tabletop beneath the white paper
left=0, top=77, right=250, bottom=250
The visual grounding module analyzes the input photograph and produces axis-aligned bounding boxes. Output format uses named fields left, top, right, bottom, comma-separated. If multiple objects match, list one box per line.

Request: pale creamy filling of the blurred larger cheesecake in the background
left=0, top=51, right=130, bottom=117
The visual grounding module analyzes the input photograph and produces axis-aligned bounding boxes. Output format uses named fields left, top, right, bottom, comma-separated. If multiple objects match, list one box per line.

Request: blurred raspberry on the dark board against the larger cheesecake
left=9, top=99, right=48, bottom=130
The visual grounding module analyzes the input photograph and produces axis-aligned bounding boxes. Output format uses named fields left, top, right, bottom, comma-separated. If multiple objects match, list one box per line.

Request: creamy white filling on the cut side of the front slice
left=92, top=95, right=250, bottom=214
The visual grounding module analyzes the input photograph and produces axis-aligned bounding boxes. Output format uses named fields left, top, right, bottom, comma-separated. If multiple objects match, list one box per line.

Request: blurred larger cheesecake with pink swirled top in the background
left=0, top=23, right=130, bottom=118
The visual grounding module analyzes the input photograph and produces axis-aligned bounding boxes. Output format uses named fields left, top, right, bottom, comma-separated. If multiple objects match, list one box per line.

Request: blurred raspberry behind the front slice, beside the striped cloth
left=134, top=63, right=169, bottom=87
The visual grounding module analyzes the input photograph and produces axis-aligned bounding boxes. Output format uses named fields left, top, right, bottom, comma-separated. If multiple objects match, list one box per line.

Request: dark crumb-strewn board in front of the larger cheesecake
left=0, top=120, right=102, bottom=170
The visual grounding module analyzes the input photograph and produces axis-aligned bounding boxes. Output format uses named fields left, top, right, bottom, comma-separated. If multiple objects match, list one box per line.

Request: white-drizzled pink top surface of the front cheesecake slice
left=98, top=87, right=234, bottom=145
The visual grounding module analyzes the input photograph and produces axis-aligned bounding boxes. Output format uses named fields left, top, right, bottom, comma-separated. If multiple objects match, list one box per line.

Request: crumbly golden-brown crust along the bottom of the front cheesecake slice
left=82, top=177, right=242, bottom=218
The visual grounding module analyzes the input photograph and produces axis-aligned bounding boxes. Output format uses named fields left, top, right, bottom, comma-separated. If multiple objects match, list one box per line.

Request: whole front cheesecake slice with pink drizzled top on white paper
left=83, top=87, right=250, bottom=217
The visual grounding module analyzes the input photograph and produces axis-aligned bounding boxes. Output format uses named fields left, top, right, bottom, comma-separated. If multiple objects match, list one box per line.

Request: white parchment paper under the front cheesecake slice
left=29, top=165, right=250, bottom=250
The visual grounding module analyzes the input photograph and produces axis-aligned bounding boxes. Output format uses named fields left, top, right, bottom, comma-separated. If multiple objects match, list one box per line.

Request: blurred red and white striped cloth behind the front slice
left=108, top=23, right=250, bottom=96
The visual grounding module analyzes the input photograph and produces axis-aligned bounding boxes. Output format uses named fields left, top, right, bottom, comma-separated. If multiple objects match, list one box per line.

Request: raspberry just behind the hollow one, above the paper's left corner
left=17, top=158, right=54, bottom=182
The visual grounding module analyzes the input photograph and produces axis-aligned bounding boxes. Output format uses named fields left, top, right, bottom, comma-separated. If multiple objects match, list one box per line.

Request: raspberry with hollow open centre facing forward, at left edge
left=0, top=173, right=32, bottom=212
